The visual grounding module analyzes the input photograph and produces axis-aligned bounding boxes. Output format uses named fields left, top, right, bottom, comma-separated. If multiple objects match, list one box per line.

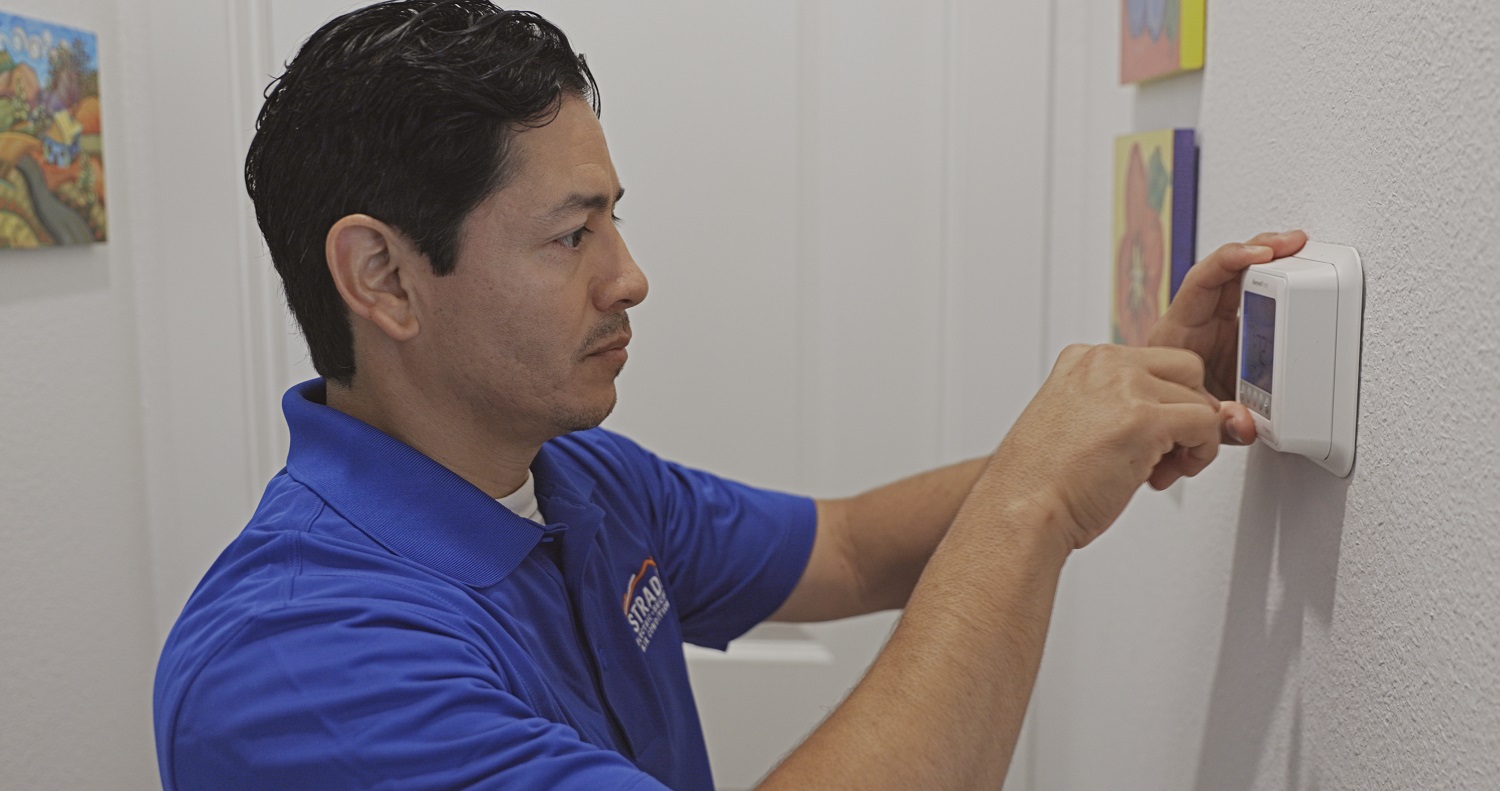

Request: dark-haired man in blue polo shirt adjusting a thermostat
left=146, top=0, right=1304, bottom=791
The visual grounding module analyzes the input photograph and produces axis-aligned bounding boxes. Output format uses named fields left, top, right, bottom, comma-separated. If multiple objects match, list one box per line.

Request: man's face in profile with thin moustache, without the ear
left=413, top=99, right=647, bottom=440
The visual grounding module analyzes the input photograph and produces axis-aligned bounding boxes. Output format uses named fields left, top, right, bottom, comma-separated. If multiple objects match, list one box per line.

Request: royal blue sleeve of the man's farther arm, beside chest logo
left=600, top=437, right=818, bottom=650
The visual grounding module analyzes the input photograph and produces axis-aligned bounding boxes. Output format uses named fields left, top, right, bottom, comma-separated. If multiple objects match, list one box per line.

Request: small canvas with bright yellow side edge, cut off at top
left=1121, top=0, right=1206, bottom=86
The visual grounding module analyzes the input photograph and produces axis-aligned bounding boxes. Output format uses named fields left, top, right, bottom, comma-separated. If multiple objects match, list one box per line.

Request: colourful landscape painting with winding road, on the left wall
left=0, top=14, right=108, bottom=248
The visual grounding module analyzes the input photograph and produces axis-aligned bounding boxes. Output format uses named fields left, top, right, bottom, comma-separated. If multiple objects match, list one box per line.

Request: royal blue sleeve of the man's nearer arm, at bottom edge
left=158, top=602, right=668, bottom=791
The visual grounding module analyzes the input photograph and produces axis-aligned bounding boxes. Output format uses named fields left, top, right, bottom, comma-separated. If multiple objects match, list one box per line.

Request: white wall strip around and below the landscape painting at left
left=0, top=0, right=156, bottom=789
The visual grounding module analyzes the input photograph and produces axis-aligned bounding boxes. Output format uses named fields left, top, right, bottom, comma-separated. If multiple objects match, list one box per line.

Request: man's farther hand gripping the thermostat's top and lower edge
left=1151, top=231, right=1308, bottom=444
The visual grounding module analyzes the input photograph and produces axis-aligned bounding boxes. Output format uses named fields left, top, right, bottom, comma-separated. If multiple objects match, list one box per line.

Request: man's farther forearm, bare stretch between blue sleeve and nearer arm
left=837, top=459, right=987, bottom=612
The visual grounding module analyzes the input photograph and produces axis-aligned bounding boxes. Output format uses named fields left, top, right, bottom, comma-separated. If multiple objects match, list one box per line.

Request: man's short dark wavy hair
left=245, top=0, right=599, bottom=386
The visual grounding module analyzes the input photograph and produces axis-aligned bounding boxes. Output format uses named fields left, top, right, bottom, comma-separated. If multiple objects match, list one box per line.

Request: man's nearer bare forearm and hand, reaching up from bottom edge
left=759, top=347, right=1221, bottom=791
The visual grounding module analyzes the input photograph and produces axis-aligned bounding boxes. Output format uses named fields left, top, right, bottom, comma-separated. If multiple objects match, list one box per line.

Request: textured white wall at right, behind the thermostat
left=1035, top=0, right=1500, bottom=791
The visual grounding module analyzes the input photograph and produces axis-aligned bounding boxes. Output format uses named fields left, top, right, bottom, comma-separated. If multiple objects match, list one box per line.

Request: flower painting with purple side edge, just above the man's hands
left=1110, top=129, right=1199, bottom=347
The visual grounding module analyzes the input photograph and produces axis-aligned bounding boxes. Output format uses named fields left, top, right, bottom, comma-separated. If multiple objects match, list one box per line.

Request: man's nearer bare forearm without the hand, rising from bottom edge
left=762, top=482, right=1068, bottom=789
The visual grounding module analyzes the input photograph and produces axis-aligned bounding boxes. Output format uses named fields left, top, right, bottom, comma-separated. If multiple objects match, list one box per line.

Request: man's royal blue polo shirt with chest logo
left=155, top=380, right=816, bottom=791
